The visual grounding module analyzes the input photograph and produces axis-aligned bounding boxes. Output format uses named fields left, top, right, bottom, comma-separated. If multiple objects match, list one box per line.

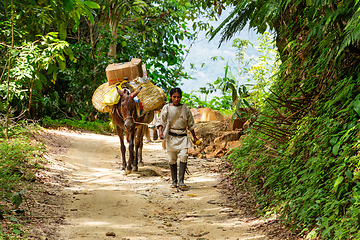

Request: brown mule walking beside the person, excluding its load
left=111, top=89, right=154, bottom=174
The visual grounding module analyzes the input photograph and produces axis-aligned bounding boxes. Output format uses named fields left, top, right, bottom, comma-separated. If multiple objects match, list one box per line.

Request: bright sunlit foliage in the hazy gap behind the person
left=199, top=32, right=279, bottom=118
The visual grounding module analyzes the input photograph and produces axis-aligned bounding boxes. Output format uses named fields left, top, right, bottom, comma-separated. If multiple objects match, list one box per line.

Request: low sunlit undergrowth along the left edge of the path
left=0, top=122, right=45, bottom=239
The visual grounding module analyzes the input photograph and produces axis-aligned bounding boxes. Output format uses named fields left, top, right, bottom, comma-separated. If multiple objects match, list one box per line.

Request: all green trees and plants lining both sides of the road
left=0, top=0, right=360, bottom=239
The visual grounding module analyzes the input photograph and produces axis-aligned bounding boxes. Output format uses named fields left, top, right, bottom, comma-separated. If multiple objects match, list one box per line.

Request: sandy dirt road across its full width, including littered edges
left=9, top=129, right=296, bottom=240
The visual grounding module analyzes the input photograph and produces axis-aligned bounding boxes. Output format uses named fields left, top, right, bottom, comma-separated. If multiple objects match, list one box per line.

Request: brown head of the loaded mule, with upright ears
left=118, top=89, right=140, bottom=131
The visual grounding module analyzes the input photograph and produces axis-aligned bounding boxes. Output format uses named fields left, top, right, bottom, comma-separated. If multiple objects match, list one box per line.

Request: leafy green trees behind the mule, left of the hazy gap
left=0, top=0, right=209, bottom=121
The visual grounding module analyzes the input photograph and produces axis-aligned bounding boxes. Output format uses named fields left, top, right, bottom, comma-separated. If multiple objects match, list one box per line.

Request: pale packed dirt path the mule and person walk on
left=45, top=131, right=268, bottom=240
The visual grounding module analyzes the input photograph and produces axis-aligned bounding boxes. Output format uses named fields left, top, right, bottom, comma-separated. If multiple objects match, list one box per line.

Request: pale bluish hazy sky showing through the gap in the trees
left=181, top=11, right=259, bottom=100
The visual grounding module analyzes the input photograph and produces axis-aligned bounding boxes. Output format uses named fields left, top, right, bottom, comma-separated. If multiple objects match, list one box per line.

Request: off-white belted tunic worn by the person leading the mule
left=156, top=104, right=196, bottom=151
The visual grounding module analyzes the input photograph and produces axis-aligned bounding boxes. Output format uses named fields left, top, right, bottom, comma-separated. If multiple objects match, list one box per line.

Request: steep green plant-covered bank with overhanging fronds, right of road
left=206, top=0, right=360, bottom=239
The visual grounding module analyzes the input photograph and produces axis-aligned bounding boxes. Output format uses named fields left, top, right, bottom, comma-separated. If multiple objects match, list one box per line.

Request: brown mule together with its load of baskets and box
left=92, top=58, right=166, bottom=174
